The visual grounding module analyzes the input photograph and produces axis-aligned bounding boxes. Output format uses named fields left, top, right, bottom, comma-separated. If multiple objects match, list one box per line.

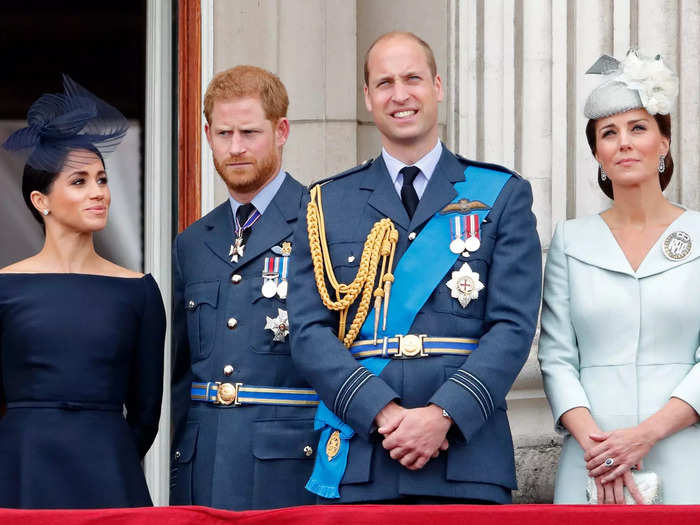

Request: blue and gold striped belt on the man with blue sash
left=350, top=334, right=479, bottom=359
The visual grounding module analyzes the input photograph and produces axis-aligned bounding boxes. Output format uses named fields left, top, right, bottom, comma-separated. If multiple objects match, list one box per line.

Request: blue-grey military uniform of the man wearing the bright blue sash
left=290, top=148, right=541, bottom=503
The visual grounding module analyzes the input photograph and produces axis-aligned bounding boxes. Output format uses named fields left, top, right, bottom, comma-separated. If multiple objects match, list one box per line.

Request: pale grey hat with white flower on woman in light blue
left=583, top=50, right=678, bottom=119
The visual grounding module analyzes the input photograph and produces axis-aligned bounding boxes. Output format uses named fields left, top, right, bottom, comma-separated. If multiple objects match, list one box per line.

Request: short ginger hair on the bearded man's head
left=204, top=66, right=289, bottom=124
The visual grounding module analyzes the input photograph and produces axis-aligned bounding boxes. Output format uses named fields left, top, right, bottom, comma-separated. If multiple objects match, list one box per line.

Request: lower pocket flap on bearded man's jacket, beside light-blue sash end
left=253, top=419, right=320, bottom=459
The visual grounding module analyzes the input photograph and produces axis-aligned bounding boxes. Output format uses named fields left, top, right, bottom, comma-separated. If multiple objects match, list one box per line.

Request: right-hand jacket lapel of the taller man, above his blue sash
left=409, top=146, right=465, bottom=231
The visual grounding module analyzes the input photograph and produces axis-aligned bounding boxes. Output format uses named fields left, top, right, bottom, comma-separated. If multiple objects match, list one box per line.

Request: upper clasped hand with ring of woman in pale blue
left=583, top=427, right=654, bottom=485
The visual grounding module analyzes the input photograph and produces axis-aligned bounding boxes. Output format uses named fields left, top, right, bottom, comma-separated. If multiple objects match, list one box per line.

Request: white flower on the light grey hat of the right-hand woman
left=616, top=51, right=678, bottom=115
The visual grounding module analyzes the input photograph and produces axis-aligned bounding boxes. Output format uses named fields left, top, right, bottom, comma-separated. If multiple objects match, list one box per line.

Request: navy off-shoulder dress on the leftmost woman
left=0, top=274, right=165, bottom=508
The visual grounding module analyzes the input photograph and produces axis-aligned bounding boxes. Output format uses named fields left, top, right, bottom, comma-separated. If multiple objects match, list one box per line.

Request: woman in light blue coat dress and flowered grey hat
left=539, top=52, right=700, bottom=504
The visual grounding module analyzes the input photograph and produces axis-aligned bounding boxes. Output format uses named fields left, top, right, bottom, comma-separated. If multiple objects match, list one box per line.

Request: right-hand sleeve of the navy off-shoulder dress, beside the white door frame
left=126, top=275, right=165, bottom=457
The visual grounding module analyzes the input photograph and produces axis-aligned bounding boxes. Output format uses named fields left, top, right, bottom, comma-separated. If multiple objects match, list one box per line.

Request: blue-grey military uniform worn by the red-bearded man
left=170, top=174, right=318, bottom=510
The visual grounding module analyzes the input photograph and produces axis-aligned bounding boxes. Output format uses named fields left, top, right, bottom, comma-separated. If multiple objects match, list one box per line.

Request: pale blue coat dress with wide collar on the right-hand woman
left=539, top=210, right=700, bottom=504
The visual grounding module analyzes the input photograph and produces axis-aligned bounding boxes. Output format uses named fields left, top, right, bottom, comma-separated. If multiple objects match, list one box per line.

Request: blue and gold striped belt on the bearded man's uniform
left=190, top=381, right=318, bottom=407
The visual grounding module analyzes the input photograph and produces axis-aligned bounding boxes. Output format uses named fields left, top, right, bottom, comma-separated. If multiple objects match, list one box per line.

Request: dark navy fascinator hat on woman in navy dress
left=3, top=75, right=129, bottom=173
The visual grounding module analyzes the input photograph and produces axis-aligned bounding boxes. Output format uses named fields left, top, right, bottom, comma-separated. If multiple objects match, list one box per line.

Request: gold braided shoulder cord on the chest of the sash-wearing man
left=306, top=185, right=399, bottom=348
